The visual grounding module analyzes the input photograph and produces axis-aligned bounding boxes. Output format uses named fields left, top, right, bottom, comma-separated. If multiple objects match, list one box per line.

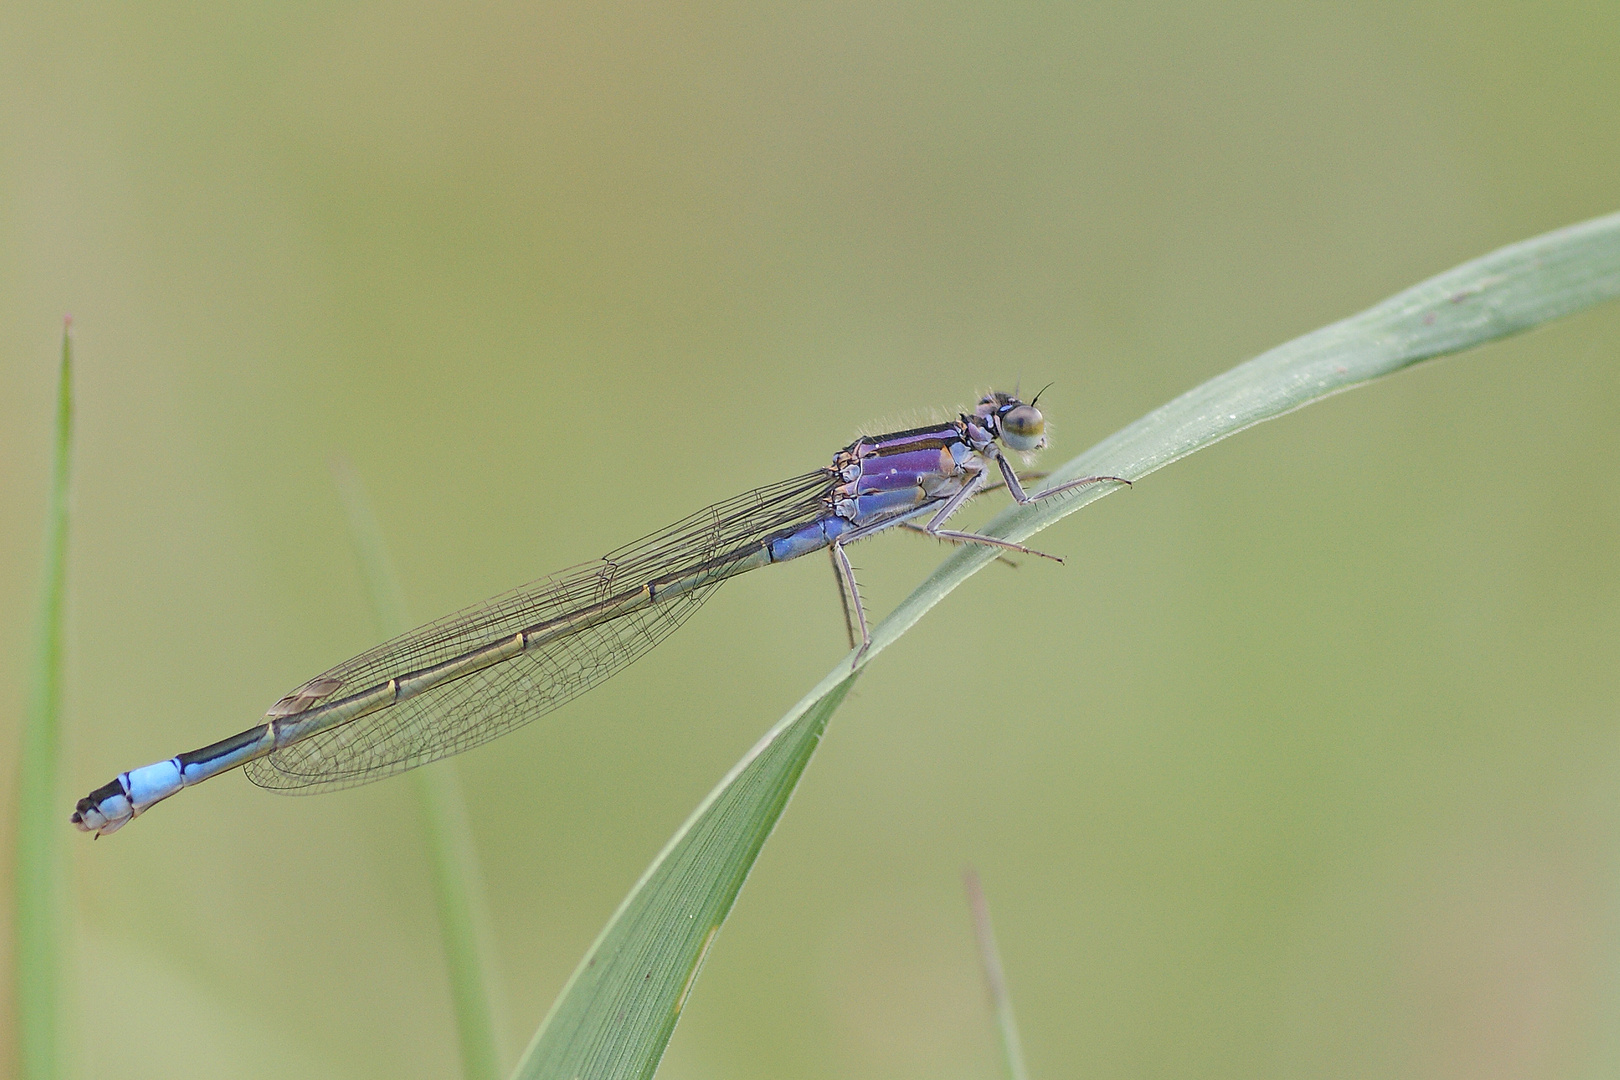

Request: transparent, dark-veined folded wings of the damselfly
left=246, top=470, right=836, bottom=793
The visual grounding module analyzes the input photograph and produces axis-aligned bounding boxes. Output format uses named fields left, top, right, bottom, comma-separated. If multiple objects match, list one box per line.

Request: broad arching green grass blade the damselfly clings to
left=515, top=214, right=1620, bottom=1080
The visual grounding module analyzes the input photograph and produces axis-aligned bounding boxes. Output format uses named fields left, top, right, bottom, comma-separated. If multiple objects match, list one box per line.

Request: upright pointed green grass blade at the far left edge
left=11, top=327, right=73, bottom=1080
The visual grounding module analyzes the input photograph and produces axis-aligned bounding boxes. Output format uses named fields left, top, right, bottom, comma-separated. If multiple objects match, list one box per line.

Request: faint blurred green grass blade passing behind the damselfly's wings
left=332, top=458, right=501, bottom=1080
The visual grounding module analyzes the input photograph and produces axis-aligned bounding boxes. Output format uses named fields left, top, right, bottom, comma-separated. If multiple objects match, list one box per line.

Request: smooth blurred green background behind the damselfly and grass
left=0, top=2, right=1620, bottom=1078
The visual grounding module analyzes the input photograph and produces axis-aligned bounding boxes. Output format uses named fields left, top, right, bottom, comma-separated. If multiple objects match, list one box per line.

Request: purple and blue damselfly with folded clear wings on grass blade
left=71, top=393, right=1129, bottom=834
